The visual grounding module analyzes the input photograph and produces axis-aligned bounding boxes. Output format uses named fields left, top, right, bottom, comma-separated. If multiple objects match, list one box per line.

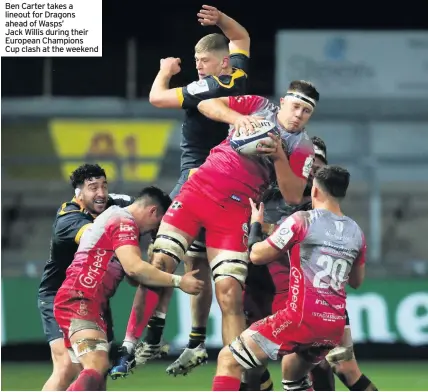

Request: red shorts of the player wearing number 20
left=248, top=309, right=345, bottom=364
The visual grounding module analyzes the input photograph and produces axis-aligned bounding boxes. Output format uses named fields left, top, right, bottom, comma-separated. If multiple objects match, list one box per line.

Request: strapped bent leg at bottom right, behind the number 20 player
left=326, top=325, right=377, bottom=391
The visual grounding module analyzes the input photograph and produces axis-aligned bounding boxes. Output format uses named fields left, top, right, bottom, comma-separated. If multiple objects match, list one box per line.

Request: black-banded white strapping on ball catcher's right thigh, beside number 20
left=210, top=250, right=248, bottom=287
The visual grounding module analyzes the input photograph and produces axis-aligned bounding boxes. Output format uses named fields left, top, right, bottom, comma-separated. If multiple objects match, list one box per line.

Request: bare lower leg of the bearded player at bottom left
left=42, top=338, right=81, bottom=391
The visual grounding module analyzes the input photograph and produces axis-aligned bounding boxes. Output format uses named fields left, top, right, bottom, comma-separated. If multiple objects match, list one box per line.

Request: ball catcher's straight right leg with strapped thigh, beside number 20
left=207, top=248, right=248, bottom=345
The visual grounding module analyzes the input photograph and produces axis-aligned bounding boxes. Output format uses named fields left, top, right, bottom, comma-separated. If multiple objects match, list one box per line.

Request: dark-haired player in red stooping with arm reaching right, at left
left=54, top=187, right=203, bottom=391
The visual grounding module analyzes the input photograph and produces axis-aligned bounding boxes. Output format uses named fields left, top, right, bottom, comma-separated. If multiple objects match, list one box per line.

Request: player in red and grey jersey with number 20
left=213, top=166, right=366, bottom=391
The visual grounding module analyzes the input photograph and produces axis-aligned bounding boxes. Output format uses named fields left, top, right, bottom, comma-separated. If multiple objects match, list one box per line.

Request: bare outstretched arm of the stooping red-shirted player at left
left=115, top=245, right=204, bottom=295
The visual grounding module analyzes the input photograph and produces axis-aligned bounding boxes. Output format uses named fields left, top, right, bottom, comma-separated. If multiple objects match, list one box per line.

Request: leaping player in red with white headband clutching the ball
left=137, top=81, right=319, bottom=376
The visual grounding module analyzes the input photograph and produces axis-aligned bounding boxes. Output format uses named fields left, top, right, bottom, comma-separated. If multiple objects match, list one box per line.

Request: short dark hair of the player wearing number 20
left=314, top=165, right=351, bottom=199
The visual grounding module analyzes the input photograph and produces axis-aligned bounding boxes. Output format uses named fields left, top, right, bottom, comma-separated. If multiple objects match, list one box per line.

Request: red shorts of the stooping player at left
left=54, top=289, right=107, bottom=348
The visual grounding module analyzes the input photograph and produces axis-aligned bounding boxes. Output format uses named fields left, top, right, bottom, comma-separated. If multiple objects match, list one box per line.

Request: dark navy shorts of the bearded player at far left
left=37, top=296, right=114, bottom=343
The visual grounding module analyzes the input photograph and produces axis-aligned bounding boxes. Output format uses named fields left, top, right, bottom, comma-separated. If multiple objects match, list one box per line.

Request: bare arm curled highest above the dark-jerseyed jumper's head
left=198, top=5, right=250, bottom=57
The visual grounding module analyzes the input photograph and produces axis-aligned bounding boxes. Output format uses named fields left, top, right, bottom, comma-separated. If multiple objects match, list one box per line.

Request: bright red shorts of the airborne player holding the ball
left=163, top=184, right=251, bottom=252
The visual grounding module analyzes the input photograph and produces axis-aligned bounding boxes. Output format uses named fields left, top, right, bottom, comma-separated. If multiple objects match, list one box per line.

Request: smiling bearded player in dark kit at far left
left=38, top=164, right=133, bottom=391
